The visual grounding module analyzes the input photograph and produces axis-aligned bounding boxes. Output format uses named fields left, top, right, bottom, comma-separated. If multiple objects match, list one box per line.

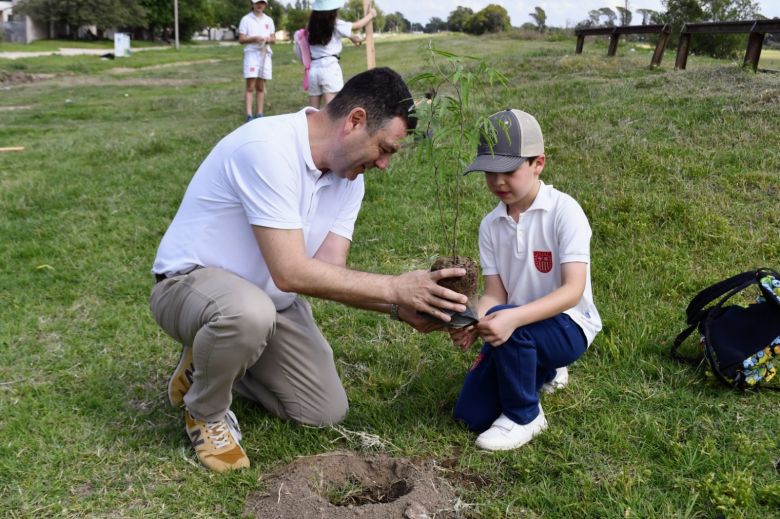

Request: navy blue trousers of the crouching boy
left=453, top=305, right=587, bottom=432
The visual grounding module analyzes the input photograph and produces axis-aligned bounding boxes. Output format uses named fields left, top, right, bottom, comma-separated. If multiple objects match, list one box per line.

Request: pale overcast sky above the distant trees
left=374, top=0, right=780, bottom=27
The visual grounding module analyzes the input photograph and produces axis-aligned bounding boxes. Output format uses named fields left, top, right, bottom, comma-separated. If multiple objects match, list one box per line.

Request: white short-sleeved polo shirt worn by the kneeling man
left=152, top=107, right=364, bottom=310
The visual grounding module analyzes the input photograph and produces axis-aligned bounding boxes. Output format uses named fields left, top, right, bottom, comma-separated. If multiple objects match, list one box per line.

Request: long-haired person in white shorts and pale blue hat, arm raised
left=307, top=0, right=376, bottom=108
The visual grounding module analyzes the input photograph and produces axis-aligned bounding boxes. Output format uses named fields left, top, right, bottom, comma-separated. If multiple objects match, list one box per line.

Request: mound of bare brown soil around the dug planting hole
left=244, top=451, right=464, bottom=519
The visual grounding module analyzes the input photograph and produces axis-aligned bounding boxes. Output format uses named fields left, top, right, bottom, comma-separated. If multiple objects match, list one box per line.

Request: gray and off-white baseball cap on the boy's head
left=464, top=109, right=544, bottom=174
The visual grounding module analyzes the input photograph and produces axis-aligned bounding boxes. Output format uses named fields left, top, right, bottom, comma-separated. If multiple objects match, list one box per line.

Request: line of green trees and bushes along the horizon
left=14, top=0, right=763, bottom=57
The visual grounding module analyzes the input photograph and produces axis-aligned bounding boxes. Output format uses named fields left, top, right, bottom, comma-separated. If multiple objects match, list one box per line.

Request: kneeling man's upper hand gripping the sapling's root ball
left=394, top=268, right=468, bottom=322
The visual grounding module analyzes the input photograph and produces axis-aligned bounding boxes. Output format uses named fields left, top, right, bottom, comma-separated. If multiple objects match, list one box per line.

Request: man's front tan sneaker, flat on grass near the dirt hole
left=184, top=409, right=249, bottom=472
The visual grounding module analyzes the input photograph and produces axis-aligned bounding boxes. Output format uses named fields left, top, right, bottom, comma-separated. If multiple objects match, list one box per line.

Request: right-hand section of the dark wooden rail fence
left=674, top=19, right=780, bottom=72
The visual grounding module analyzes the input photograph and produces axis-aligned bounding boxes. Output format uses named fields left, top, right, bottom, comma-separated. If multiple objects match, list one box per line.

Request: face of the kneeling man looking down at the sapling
left=331, top=117, right=406, bottom=180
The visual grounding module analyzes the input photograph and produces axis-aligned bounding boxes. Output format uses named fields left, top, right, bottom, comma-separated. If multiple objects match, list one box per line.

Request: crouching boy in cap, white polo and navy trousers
left=450, top=110, right=601, bottom=450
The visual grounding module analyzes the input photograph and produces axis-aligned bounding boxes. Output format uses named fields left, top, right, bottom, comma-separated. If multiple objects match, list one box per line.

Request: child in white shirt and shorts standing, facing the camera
left=238, top=0, right=276, bottom=121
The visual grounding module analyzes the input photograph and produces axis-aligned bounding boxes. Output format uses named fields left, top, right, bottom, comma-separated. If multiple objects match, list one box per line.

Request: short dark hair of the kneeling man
left=325, top=67, right=417, bottom=133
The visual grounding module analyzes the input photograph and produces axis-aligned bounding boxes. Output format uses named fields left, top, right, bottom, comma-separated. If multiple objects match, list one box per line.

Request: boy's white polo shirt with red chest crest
left=479, top=182, right=601, bottom=345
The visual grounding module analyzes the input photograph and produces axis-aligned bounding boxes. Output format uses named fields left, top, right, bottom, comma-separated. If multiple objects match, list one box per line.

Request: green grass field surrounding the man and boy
left=0, top=36, right=780, bottom=518
